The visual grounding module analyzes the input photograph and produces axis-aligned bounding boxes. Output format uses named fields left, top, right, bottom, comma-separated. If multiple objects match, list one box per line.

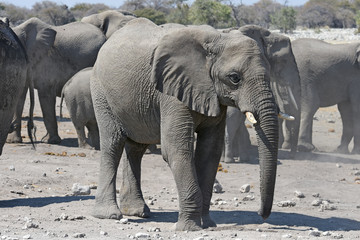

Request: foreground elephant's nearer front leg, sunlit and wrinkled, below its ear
left=161, top=103, right=202, bottom=231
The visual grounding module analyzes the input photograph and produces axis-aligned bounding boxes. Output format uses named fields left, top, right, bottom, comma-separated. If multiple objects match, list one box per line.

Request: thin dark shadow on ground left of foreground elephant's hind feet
left=0, top=196, right=95, bottom=208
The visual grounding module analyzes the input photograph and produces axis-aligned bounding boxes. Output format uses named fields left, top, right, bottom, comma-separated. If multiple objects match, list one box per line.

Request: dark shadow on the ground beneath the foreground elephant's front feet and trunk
left=131, top=210, right=360, bottom=231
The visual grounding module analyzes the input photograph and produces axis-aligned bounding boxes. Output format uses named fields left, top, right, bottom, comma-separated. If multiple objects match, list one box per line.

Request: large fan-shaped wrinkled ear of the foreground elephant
left=151, top=28, right=220, bottom=116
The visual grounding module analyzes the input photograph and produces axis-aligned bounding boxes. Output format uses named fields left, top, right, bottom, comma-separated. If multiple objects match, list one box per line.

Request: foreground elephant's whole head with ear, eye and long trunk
left=151, top=28, right=278, bottom=219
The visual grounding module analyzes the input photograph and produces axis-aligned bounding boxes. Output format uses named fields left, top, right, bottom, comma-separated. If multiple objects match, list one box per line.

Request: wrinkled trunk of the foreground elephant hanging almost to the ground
left=255, top=93, right=279, bottom=219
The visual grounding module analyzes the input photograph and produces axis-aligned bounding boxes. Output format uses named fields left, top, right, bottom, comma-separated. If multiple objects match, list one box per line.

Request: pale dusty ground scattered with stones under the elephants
left=0, top=90, right=360, bottom=240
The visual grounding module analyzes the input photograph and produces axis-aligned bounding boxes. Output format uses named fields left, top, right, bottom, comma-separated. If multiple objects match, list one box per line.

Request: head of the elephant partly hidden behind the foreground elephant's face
left=239, top=25, right=300, bottom=152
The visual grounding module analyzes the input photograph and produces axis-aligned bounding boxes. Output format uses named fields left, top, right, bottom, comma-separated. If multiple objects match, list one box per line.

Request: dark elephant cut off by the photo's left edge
left=0, top=20, right=27, bottom=155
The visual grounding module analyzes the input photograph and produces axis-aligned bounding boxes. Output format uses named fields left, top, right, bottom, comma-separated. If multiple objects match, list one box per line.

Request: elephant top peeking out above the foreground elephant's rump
left=81, top=10, right=135, bottom=38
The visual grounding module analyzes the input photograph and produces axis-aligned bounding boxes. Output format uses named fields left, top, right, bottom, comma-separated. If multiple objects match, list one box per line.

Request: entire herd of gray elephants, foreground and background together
left=0, top=8, right=360, bottom=230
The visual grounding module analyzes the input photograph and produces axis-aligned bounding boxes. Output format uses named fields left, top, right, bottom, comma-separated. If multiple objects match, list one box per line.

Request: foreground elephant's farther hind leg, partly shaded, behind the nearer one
left=120, top=140, right=150, bottom=218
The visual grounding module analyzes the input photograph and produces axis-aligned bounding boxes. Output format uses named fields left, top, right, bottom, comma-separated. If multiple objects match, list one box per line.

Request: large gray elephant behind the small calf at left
left=7, top=18, right=106, bottom=144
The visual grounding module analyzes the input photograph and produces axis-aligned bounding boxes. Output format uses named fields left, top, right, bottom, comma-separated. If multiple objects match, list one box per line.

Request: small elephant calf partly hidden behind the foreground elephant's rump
left=60, top=67, right=100, bottom=150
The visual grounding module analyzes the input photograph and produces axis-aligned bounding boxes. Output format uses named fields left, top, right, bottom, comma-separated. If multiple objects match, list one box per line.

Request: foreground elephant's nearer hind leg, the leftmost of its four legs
left=92, top=78, right=126, bottom=219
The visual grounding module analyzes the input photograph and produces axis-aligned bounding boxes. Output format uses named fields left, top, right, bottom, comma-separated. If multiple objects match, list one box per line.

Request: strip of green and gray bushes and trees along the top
left=0, top=0, right=360, bottom=32
